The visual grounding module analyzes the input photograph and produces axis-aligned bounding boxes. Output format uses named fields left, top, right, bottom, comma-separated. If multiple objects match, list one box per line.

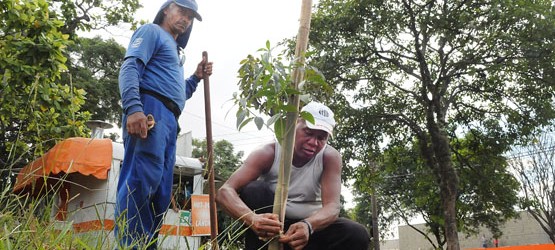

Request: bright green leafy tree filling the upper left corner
left=0, top=0, right=140, bottom=184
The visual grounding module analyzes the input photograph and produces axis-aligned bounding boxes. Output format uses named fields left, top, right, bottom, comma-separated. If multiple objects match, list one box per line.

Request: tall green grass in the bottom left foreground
left=0, top=180, right=252, bottom=250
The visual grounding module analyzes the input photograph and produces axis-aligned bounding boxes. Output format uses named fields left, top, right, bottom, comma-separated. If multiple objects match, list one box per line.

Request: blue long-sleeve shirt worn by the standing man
left=119, top=24, right=200, bottom=115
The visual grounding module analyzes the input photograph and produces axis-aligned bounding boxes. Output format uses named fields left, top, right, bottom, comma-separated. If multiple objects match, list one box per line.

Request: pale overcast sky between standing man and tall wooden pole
left=95, top=0, right=352, bottom=207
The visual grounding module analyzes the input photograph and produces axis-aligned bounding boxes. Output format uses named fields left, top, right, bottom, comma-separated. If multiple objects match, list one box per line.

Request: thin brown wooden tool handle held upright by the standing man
left=202, top=51, right=219, bottom=250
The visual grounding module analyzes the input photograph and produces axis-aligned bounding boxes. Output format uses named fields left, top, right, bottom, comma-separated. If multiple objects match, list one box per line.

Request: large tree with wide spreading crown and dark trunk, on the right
left=310, top=0, right=555, bottom=249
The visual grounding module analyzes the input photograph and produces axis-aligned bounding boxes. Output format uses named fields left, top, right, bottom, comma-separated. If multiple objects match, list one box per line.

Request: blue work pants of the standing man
left=114, top=94, right=178, bottom=249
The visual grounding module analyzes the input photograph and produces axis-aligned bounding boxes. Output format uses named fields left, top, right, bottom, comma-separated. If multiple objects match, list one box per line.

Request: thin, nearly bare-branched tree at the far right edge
left=510, top=134, right=555, bottom=244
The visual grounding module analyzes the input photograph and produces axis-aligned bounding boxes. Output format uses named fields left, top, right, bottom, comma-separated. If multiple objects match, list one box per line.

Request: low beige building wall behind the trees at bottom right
left=381, top=212, right=552, bottom=250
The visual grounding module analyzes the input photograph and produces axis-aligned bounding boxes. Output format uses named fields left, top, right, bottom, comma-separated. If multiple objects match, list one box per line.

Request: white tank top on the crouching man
left=258, top=142, right=327, bottom=219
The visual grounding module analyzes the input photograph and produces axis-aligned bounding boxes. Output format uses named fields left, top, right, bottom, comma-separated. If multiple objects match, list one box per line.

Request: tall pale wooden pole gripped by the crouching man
left=268, top=0, right=312, bottom=250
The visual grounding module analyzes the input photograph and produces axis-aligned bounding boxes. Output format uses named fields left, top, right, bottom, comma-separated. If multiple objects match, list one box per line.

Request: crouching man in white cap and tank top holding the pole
left=216, top=102, right=370, bottom=250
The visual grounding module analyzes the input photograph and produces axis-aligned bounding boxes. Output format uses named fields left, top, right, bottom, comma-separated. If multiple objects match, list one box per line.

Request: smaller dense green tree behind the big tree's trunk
left=370, top=134, right=519, bottom=249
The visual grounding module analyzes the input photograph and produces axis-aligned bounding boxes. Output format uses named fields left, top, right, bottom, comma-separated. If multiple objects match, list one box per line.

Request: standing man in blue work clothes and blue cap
left=115, top=0, right=212, bottom=249
